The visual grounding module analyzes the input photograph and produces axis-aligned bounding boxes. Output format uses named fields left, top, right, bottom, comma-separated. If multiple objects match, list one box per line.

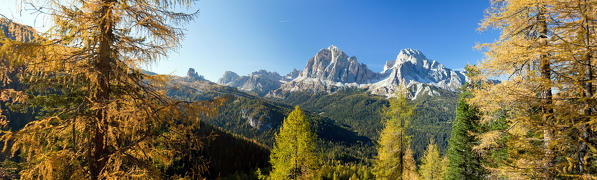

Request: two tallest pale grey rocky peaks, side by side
left=271, top=46, right=466, bottom=98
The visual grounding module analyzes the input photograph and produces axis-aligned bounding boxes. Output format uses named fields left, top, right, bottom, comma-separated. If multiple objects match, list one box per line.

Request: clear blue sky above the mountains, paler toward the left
left=0, top=0, right=498, bottom=81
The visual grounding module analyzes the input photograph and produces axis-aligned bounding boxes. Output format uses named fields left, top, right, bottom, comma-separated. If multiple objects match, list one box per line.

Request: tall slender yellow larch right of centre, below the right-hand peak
left=373, top=86, right=417, bottom=179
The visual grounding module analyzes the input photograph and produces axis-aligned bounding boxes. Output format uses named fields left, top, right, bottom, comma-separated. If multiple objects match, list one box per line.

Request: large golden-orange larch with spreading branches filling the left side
left=0, top=0, right=222, bottom=179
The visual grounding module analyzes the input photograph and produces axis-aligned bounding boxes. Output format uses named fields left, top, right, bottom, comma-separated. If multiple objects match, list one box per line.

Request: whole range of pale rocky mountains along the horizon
left=218, top=46, right=467, bottom=98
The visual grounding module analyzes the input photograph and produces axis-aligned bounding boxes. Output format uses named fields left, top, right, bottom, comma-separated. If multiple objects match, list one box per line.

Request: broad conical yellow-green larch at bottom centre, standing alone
left=270, top=106, right=318, bottom=179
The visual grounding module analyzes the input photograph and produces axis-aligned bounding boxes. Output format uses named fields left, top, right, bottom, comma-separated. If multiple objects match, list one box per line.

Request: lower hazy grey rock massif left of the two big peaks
left=218, top=70, right=282, bottom=96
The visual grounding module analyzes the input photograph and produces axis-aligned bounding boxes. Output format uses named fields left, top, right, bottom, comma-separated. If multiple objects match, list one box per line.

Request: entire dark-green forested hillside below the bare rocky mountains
left=169, top=74, right=458, bottom=161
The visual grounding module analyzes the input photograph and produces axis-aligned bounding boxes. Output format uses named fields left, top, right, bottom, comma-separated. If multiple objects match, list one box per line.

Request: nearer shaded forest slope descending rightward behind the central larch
left=168, top=78, right=373, bottom=161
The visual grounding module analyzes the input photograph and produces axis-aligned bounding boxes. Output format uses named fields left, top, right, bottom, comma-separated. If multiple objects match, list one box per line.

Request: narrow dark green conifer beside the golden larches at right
left=446, top=91, right=484, bottom=179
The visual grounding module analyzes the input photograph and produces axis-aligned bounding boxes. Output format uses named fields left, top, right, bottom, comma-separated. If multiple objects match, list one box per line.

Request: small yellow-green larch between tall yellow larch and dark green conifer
left=419, top=138, right=446, bottom=180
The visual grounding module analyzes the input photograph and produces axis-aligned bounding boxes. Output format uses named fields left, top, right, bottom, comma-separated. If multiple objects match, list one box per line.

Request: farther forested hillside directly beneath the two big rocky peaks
left=278, top=88, right=458, bottom=159
